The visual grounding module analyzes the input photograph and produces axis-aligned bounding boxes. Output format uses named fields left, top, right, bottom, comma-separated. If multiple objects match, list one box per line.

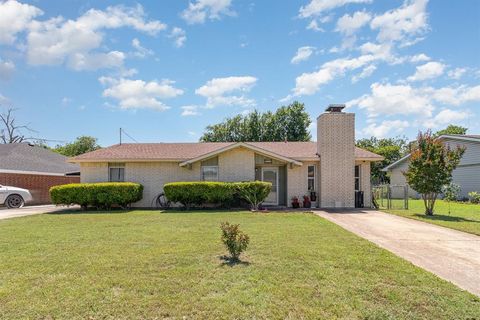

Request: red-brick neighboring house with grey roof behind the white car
left=0, top=143, right=80, bottom=204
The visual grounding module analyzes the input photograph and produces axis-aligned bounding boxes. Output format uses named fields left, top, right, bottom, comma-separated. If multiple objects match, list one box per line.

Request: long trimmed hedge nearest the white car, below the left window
left=50, top=182, right=143, bottom=209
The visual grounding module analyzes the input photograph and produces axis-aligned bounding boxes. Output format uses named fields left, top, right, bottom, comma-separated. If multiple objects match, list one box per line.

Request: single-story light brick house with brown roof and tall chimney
left=70, top=105, right=383, bottom=207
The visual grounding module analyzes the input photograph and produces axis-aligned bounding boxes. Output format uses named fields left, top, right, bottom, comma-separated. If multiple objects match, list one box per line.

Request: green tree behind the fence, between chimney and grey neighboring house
left=356, top=137, right=408, bottom=184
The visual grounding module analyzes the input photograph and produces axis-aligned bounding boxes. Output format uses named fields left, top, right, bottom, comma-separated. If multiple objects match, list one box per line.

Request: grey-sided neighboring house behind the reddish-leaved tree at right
left=383, top=135, right=480, bottom=198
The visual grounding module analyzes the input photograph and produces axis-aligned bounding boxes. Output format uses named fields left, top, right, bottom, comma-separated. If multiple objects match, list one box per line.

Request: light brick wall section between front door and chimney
left=287, top=161, right=320, bottom=207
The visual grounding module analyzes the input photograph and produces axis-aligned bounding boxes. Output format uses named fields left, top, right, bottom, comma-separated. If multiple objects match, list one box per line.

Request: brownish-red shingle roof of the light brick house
left=72, top=142, right=382, bottom=161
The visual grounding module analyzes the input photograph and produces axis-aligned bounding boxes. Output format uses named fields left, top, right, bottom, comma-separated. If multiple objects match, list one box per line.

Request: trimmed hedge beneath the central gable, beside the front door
left=163, top=181, right=272, bottom=209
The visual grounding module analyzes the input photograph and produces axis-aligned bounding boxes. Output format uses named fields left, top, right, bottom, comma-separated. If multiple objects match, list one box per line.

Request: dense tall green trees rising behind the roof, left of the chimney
left=200, top=101, right=312, bottom=142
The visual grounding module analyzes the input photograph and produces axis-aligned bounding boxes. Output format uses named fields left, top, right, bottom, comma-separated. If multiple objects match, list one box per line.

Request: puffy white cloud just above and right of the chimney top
left=347, top=83, right=435, bottom=117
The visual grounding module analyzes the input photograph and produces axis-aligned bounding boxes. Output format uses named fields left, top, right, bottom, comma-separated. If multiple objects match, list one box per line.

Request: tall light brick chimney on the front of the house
left=317, top=104, right=355, bottom=208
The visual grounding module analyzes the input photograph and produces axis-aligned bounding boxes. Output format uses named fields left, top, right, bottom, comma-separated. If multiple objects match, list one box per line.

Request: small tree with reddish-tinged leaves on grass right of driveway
left=404, top=131, right=465, bottom=216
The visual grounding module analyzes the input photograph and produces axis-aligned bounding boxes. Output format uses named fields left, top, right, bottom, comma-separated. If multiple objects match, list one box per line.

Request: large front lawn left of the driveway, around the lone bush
left=0, top=211, right=480, bottom=319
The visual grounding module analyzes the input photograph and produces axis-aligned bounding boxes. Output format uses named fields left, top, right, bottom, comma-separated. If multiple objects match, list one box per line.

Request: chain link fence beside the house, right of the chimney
left=372, top=184, right=408, bottom=210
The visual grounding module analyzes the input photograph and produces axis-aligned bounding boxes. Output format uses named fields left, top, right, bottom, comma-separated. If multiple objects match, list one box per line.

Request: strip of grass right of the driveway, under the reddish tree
left=382, top=199, right=480, bottom=235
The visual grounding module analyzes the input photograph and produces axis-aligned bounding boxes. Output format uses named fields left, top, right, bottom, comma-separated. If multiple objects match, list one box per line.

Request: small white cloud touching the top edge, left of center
left=181, top=0, right=235, bottom=24
